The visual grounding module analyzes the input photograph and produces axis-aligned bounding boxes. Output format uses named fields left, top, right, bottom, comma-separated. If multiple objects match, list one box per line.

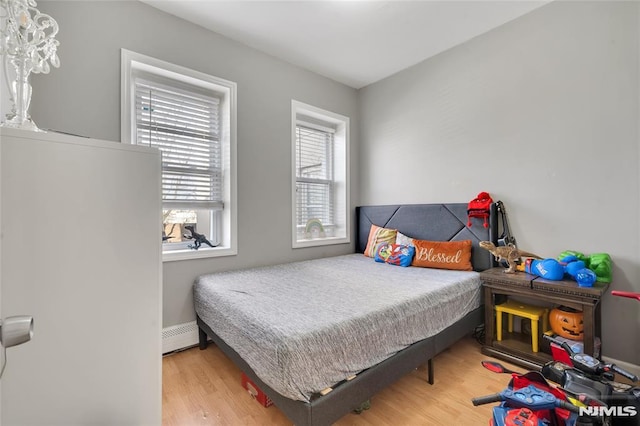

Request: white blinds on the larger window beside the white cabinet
left=135, top=77, right=222, bottom=209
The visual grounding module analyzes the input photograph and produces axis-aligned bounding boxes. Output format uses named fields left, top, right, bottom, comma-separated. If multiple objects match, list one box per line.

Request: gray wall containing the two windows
left=31, top=1, right=358, bottom=327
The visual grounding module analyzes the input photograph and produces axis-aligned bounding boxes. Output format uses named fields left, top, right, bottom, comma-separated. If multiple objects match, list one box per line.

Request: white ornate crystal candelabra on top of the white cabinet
left=0, top=0, right=60, bottom=131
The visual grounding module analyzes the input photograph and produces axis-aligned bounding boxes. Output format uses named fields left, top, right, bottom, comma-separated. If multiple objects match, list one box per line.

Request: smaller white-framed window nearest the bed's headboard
left=292, top=101, right=350, bottom=247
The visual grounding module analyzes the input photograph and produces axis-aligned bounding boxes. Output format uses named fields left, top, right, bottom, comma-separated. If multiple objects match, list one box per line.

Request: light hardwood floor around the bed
left=162, top=337, right=523, bottom=426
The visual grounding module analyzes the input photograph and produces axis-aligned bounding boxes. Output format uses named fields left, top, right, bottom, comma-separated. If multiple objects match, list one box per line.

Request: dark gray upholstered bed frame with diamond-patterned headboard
left=197, top=203, right=497, bottom=426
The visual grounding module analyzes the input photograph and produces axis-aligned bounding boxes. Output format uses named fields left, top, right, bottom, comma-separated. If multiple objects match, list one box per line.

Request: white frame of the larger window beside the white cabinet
left=120, top=49, right=238, bottom=261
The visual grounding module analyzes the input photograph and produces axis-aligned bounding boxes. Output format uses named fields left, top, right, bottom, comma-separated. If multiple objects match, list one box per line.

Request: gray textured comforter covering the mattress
left=194, top=254, right=481, bottom=401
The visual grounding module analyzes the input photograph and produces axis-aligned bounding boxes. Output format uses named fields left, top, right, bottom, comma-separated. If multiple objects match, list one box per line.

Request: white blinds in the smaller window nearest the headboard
left=296, top=124, right=333, bottom=226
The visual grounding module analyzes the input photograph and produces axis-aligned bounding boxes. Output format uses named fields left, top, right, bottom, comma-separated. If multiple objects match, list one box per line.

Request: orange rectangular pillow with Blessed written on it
left=411, top=239, right=473, bottom=271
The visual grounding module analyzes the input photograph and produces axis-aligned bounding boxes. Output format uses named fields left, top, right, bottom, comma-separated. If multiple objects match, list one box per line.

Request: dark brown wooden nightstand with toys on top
left=480, top=267, right=609, bottom=369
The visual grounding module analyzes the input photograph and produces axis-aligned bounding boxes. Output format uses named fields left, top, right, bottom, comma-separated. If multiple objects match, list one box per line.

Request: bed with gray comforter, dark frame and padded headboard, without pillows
left=194, top=203, right=497, bottom=425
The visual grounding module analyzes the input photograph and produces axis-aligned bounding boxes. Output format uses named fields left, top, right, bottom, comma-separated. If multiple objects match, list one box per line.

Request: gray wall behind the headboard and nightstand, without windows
left=359, top=2, right=640, bottom=364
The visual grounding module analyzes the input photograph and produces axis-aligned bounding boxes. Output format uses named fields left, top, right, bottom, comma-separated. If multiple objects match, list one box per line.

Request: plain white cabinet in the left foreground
left=0, top=129, right=162, bottom=426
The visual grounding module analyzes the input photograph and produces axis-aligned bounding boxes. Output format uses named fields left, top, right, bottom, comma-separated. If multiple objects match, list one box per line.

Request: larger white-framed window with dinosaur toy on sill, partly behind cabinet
left=122, top=50, right=236, bottom=260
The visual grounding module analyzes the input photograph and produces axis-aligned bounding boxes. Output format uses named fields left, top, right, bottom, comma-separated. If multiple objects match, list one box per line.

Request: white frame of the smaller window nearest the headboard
left=291, top=100, right=351, bottom=248
